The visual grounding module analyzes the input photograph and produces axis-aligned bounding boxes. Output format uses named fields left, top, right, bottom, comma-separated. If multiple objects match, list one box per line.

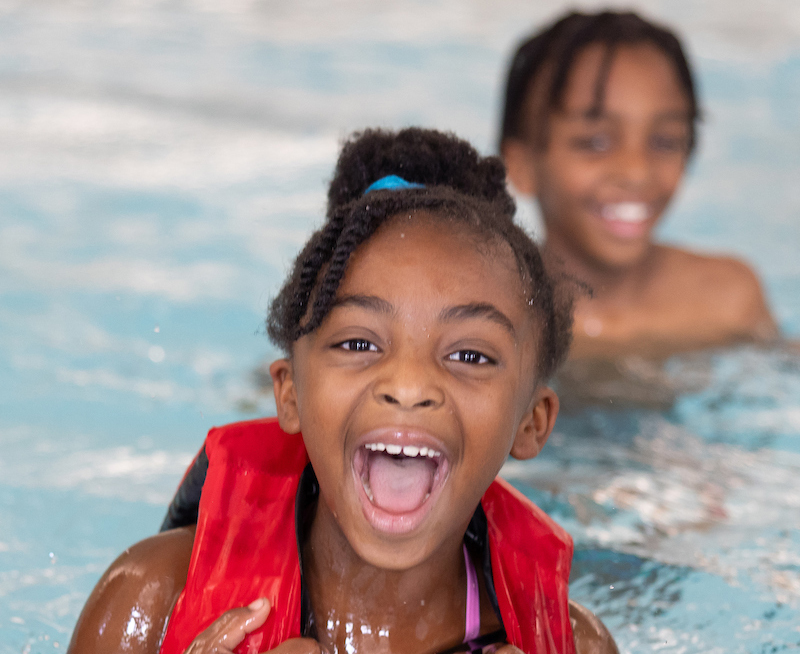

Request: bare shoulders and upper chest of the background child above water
left=571, top=245, right=778, bottom=360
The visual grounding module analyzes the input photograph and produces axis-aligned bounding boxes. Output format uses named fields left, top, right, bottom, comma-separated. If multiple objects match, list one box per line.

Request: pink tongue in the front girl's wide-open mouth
left=369, top=452, right=436, bottom=513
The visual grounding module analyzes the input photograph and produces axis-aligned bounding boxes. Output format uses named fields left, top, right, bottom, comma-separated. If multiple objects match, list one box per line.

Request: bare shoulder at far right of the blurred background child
left=660, top=246, right=777, bottom=340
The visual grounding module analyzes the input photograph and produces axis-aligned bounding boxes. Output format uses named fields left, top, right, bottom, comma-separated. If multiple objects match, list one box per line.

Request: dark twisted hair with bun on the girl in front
left=267, top=128, right=572, bottom=379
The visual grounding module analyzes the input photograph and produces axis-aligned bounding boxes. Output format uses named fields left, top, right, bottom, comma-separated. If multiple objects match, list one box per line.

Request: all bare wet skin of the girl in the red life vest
left=70, top=213, right=616, bottom=654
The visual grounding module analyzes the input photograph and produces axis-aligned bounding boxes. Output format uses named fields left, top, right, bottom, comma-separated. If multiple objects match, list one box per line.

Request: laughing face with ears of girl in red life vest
left=271, top=218, right=557, bottom=569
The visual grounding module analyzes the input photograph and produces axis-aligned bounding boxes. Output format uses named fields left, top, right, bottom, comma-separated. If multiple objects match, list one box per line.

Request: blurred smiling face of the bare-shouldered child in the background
left=504, top=44, right=690, bottom=269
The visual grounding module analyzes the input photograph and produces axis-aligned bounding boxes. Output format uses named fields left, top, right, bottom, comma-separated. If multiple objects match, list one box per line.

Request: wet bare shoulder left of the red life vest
left=68, top=527, right=194, bottom=654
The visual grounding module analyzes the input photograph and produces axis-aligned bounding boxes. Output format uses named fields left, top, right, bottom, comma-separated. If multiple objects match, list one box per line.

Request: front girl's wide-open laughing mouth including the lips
left=353, top=441, right=448, bottom=532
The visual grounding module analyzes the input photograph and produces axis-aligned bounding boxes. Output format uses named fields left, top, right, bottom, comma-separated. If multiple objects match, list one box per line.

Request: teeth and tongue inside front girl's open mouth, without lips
left=353, top=442, right=446, bottom=515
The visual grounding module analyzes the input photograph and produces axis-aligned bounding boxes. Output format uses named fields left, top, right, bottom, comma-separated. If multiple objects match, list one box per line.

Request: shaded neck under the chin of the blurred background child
left=544, top=234, right=658, bottom=304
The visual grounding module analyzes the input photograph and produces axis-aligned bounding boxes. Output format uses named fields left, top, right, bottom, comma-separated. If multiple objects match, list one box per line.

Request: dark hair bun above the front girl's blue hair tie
left=328, top=127, right=507, bottom=217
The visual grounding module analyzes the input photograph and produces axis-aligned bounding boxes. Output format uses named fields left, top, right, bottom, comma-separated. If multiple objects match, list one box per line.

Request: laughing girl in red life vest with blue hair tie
left=70, top=129, right=616, bottom=654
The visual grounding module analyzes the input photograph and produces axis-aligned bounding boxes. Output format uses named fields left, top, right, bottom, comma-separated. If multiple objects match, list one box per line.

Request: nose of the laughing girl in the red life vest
left=373, top=352, right=445, bottom=410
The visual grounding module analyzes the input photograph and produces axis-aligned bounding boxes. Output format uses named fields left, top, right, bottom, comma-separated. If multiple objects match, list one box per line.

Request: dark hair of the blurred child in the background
left=500, top=11, right=700, bottom=153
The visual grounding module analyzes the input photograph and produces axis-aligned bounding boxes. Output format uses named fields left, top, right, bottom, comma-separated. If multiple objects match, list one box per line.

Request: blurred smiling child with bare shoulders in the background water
left=501, top=11, right=777, bottom=358
